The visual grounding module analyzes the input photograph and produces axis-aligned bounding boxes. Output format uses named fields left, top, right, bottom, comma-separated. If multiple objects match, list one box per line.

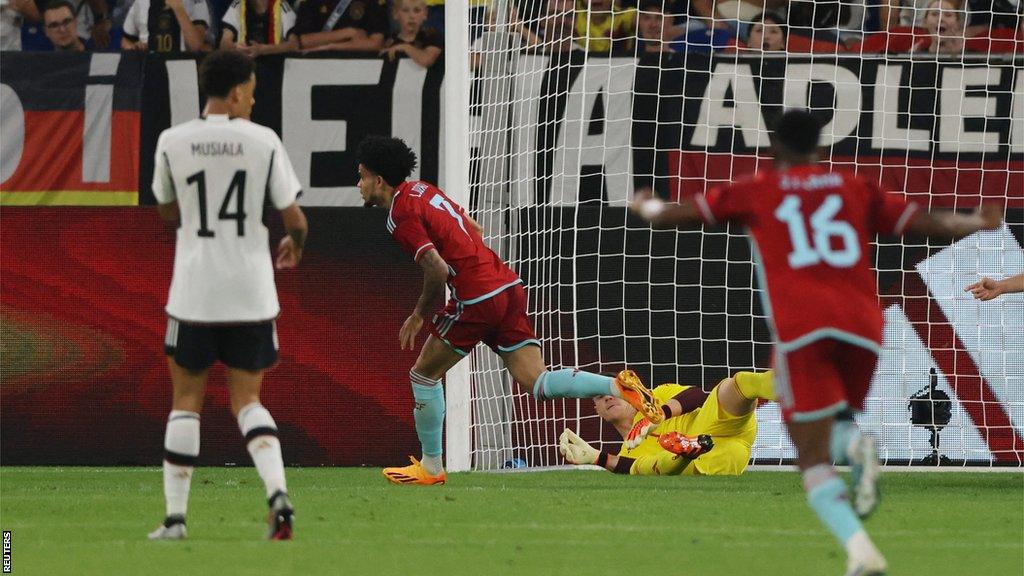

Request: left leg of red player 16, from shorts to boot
left=775, top=340, right=886, bottom=575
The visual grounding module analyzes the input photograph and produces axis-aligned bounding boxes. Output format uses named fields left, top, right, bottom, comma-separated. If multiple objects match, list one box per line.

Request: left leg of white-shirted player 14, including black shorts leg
left=150, top=319, right=214, bottom=540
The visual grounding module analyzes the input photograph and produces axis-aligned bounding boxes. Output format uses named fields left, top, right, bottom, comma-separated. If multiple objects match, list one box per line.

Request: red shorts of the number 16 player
left=775, top=338, right=879, bottom=422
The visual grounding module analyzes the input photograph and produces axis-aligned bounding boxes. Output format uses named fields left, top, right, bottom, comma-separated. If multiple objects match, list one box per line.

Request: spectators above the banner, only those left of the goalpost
left=0, top=0, right=444, bottom=67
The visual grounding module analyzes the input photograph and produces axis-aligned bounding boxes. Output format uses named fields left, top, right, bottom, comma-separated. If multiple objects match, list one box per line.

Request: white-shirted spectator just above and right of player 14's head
left=220, top=0, right=295, bottom=50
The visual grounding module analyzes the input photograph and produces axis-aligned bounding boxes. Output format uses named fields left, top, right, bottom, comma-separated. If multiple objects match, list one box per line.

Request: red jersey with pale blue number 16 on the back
left=694, top=166, right=919, bottom=348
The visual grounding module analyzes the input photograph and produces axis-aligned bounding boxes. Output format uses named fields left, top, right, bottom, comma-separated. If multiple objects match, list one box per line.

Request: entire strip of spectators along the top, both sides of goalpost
left=0, top=0, right=1024, bottom=57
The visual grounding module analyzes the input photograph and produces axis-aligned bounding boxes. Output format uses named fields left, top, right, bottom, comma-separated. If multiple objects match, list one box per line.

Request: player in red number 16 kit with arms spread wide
left=633, top=110, right=1002, bottom=576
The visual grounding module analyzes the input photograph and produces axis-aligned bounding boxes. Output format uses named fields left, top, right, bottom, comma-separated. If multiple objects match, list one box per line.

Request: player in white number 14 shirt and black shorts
left=150, top=51, right=307, bottom=540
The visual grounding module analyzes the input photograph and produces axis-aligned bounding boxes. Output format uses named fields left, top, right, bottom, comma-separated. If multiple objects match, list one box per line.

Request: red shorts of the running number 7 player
left=428, top=284, right=541, bottom=356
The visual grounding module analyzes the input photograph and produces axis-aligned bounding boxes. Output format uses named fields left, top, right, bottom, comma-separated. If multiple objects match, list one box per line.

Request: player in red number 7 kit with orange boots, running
left=358, top=136, right=664, bottom=485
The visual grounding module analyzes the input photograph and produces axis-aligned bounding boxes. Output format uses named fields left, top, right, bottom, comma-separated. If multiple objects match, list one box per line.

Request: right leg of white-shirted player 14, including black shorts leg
left=219, top=322, right=294, bottom=540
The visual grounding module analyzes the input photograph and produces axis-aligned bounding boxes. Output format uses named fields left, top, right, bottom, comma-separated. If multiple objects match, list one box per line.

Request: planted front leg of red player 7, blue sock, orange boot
left=384, top=329, right=464, bottom=485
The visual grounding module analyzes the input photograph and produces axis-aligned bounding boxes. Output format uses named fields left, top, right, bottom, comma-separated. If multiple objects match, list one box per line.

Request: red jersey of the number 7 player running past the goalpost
left=387, top=180, right=521, bottom=304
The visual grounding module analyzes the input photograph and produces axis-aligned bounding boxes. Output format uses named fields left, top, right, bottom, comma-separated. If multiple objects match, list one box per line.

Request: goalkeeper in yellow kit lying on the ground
left=558, top=371, right=775, bottom=476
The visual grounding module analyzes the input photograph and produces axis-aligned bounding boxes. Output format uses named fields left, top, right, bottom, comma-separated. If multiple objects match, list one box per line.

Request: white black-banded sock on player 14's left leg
left=164, top=410, right=199, bottom=518
